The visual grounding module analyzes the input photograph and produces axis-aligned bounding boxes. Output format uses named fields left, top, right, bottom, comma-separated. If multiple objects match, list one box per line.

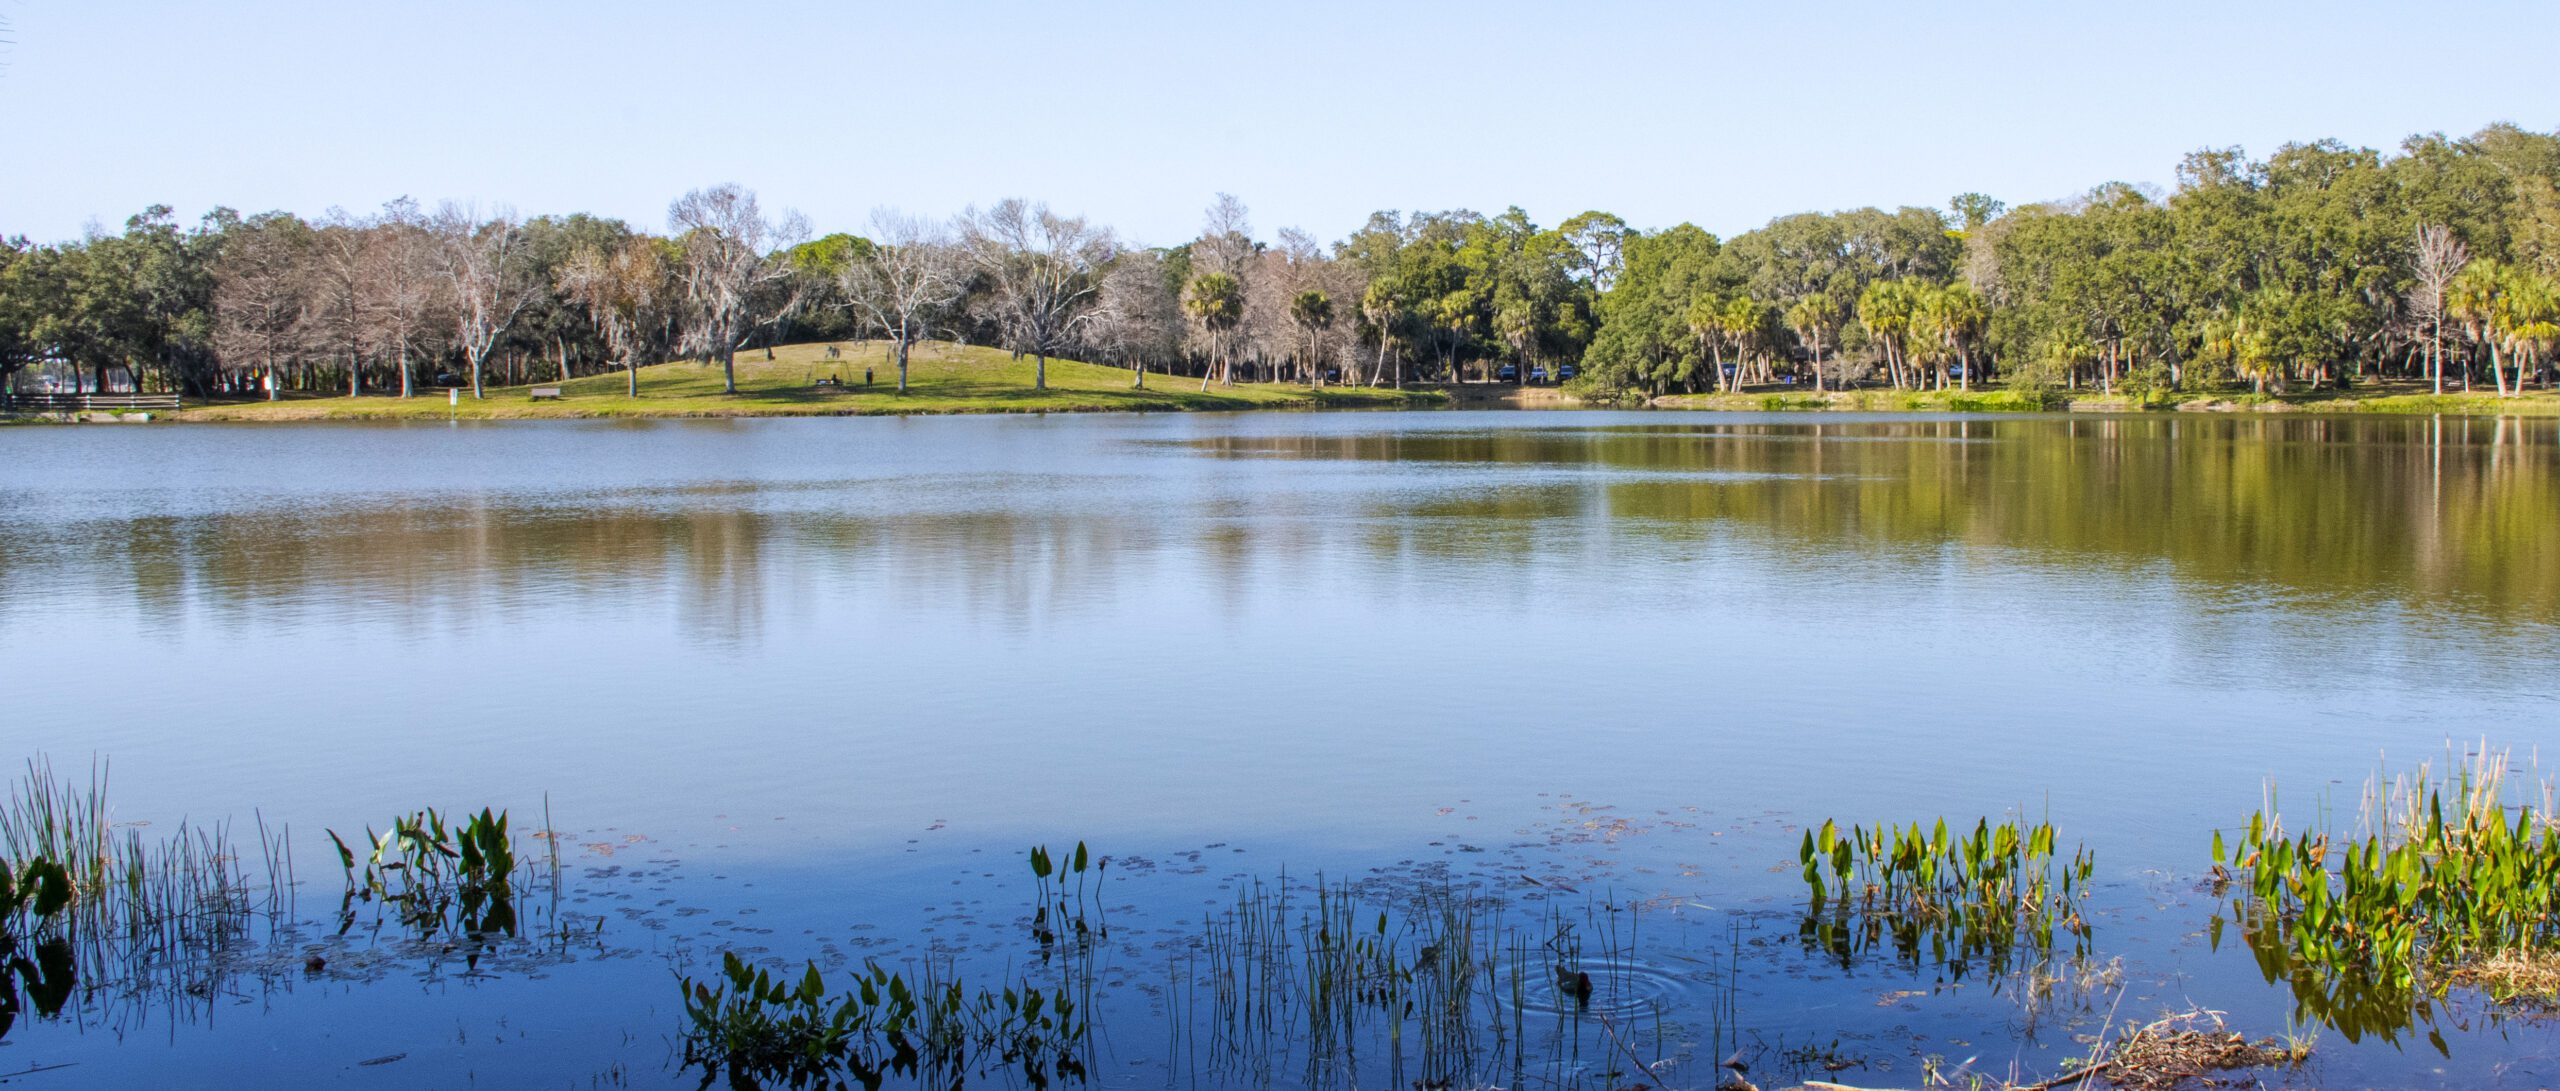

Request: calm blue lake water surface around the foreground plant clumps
left=0, top=412, right=2560, bottom=1088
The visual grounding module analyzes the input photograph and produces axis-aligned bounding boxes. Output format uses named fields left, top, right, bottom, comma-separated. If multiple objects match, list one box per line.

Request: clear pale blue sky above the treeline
left=0, top=0, right=2560, bottom=243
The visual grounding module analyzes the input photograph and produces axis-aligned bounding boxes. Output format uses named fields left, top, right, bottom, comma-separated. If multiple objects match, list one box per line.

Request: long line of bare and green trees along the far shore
left=0, top=125, right=2560, bottom=397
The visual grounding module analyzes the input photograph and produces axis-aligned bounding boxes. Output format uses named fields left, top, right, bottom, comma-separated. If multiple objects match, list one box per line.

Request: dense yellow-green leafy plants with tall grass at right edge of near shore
left=2212, top=748, right=2560, bottom=1040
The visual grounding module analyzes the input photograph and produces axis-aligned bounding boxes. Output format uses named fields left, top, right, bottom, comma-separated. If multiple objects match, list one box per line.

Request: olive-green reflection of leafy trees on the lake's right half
left=1203, top=415, right=2560, bottom=620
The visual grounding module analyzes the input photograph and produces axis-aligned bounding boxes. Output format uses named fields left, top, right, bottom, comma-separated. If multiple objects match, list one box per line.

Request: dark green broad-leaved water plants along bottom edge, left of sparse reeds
left=678, top=953, right=1088, bottom=1088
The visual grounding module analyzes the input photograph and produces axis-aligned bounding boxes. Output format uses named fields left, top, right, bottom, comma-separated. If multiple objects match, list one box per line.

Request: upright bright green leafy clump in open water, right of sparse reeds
left=1797, top=820, right=2097, bottom=978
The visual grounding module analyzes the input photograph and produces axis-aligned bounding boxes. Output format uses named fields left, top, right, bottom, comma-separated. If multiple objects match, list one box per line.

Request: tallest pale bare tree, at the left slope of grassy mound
left=666, top=182, right=809, bottom=394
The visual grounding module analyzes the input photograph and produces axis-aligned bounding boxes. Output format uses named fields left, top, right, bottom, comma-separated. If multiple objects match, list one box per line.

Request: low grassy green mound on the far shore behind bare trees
left=179, top=341, right=1444, bottom=420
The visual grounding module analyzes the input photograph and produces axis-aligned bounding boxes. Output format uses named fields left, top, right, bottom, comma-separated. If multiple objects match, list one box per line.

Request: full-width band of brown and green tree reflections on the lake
left=0, top=417, right=2560, bottom=653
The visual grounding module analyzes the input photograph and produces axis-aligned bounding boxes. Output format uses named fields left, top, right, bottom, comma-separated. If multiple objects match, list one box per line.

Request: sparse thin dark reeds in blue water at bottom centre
left=1167, top=876, right=1689, bottom=1088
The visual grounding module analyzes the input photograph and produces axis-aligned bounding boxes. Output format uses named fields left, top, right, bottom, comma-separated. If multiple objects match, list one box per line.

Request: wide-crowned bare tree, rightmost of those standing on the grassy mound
left=960, top=197, right=1119, bottom=389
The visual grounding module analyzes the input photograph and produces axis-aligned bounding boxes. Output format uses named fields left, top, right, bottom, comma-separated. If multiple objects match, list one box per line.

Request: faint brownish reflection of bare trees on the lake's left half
left=0, top=497, right=1160, bottom=656
